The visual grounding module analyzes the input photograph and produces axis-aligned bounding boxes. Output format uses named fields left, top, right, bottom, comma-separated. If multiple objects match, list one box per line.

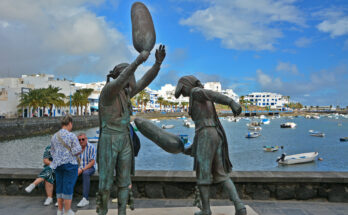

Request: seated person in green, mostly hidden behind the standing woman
left=25, top=145, right=55, bottom=206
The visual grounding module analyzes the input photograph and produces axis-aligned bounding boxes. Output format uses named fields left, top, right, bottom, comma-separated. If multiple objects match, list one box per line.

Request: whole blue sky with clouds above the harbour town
left=0, top=0, right=348, bottom=106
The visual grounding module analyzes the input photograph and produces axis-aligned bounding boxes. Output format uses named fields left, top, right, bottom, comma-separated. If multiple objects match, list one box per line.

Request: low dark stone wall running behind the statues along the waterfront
left=0, top=168, right=348, bottom=202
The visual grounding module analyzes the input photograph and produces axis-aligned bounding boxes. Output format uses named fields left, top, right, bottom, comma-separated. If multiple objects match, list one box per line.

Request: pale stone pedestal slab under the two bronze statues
left=76, top=205, right=258, bottom=215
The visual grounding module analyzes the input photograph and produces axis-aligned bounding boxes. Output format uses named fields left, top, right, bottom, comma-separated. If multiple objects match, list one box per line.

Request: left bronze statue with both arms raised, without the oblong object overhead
left=97, top=45, right=166, bottom=215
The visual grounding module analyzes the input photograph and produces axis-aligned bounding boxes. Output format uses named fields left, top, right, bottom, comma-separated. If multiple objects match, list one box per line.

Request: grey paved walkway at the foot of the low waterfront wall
left=0, top=196, right=348, bottom=215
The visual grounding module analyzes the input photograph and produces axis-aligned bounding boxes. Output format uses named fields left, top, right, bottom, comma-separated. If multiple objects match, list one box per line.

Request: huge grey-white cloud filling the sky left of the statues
left=0, top=0, right=131, bottom=78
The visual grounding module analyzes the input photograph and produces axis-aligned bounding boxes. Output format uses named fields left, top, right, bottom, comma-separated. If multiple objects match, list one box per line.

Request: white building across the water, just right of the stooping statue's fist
left=244, top=92, right=289, bottom=109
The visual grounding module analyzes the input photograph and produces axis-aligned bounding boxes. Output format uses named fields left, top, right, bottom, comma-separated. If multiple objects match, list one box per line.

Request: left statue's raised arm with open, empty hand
left=130, top=45, right=166, bottom=97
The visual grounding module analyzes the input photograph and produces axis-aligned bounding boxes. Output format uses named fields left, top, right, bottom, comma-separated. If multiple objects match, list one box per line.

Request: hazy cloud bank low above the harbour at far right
left=256, top=65, right=348, bottom=105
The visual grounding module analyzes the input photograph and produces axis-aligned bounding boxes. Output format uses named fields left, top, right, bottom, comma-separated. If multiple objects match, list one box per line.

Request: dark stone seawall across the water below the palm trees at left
left=0, top=116, right=99, bottom=141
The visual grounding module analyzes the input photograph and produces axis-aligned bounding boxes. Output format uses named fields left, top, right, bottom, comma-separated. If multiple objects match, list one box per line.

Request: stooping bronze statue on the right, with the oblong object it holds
left=135, top=76, right=246, bottom=215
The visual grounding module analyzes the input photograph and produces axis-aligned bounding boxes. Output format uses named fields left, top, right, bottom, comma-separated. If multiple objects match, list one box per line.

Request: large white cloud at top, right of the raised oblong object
left=180, top=0, right=305, bottom=50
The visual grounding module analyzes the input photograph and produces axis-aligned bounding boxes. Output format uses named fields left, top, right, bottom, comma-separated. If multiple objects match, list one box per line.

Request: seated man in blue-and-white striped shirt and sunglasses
left=77, top=133, right=95, bottom=207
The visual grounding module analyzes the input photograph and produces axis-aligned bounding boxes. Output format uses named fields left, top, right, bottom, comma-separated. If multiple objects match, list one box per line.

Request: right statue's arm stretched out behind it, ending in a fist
left=192, top=87, right=242, bottom=116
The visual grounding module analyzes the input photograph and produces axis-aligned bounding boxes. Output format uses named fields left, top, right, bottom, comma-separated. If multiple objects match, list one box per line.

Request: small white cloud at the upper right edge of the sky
left=314, top=8, right=348, bottom=38
